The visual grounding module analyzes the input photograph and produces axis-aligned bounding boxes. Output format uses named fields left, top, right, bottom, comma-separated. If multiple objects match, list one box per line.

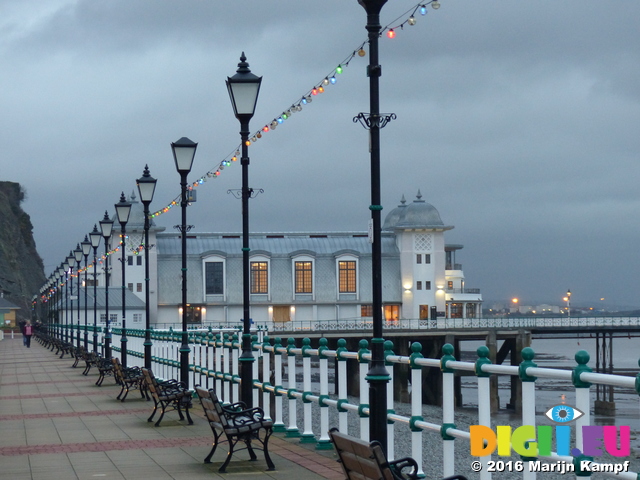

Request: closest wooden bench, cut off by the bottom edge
left=329, top=428, right=467, bottom=480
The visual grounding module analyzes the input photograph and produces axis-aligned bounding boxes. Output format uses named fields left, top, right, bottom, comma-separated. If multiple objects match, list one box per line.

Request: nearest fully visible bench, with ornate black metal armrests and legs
left=196, top=386, right=275, bottom=473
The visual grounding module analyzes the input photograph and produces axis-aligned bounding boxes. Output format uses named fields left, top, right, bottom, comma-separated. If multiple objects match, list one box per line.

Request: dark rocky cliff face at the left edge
left=0, top=182, right=46, bottom=319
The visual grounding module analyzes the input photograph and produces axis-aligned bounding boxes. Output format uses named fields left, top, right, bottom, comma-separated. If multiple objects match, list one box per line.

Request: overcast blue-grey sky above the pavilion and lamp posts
left=0, top=0, right=640, bottom=307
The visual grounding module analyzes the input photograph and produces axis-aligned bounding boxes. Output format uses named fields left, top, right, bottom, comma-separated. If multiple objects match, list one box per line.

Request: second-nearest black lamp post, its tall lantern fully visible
left=227, top=52, right=262, bottom=408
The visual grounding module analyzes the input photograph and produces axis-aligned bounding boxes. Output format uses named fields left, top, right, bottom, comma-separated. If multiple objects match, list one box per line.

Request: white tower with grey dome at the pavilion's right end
left=382, top=190, right=454, bottom=319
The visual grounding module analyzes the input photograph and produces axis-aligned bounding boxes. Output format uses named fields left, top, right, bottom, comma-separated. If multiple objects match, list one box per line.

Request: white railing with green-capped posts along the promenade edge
left=62, top=329, right=640, bottom=480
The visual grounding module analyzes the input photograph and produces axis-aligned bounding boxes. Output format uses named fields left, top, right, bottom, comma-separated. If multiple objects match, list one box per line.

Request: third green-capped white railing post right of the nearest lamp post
left=440, top=343, right=456, bottom=477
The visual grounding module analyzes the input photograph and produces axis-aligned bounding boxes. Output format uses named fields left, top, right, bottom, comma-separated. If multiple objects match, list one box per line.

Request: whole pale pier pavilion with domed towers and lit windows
left=72, top=192, right=482, bottom=326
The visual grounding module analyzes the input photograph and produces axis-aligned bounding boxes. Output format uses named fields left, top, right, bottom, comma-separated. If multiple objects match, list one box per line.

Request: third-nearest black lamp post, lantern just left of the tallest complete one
left=171, top=137, right=198, bottom=388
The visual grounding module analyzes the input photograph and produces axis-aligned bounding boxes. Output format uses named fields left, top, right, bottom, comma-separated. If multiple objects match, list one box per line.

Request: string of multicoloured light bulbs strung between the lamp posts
left=149, top=0, right=440, bottom=218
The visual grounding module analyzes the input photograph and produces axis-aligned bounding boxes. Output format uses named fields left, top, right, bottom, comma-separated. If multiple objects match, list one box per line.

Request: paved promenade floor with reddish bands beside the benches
left=0, top=335, right=344, bottom=480
